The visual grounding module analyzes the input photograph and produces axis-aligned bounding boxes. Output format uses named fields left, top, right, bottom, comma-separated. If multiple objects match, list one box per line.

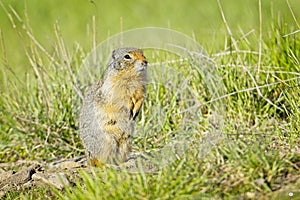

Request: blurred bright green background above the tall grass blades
left=0, top=0, right=300, bottom=76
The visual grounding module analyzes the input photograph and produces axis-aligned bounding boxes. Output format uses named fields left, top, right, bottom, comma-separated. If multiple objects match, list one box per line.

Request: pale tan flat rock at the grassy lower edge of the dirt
left=32, top=172, right=70, bottom=190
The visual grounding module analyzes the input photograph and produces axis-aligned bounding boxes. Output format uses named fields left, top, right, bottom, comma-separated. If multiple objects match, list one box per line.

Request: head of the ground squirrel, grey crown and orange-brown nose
left=108, top=47, right=148, bottom=73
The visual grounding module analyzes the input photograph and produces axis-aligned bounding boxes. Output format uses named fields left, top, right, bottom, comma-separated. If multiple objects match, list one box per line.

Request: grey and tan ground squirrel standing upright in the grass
left=79, top=48, right=147, bottom=167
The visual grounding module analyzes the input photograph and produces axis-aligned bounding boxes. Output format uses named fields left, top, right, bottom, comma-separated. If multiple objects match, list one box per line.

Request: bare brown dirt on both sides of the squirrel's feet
left=0, top=155, right=157, bottom=198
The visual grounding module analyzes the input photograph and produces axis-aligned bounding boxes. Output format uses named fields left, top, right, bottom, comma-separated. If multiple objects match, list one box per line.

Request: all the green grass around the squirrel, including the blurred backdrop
left=0, top=0, right=300, bottom=199
